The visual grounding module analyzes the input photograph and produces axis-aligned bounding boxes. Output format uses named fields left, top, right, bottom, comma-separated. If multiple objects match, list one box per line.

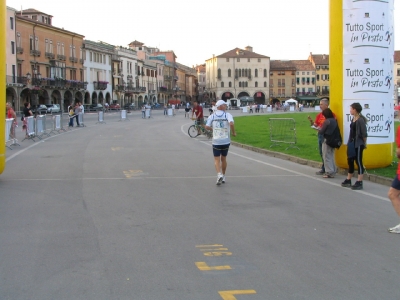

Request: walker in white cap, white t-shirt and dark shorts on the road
left=206, top=100, right=236, bottom=185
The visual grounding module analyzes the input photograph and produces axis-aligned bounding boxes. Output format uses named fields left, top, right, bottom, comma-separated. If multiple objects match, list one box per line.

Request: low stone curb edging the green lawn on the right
left=231, top=141, right=393, bottom=186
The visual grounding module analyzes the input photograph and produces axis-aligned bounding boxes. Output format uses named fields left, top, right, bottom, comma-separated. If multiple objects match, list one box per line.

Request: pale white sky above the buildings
left=6, top=0, right=400, bottom=67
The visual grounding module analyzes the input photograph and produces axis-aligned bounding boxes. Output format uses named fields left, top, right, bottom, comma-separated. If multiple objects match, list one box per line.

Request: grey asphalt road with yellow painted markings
left=0, top=110, right=400, bottom=300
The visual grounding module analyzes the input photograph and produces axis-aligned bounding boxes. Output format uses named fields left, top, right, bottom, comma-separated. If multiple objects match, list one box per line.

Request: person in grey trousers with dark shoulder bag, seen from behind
left=318, top=108, right=338, bottom=178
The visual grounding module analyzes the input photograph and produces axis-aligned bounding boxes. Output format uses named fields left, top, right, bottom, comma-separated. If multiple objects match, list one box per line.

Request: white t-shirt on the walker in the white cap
left=206, top=110, right=233, bottom=145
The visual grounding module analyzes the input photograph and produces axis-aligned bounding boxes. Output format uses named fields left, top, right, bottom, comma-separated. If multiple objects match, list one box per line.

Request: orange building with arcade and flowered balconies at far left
left=7, top=9, right=86, bottom=110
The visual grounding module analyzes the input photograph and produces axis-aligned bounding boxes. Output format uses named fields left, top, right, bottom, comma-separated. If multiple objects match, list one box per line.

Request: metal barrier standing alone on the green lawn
left=269, top=118, right=300, bottom=150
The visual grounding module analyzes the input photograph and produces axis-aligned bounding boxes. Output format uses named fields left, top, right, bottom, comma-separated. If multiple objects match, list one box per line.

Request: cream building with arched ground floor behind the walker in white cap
left=205, top=46, right=270, bottom=106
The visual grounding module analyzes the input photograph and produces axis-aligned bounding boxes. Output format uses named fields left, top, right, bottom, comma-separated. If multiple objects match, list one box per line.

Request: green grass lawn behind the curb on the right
left=232, top=112, right=400, bottom=178
